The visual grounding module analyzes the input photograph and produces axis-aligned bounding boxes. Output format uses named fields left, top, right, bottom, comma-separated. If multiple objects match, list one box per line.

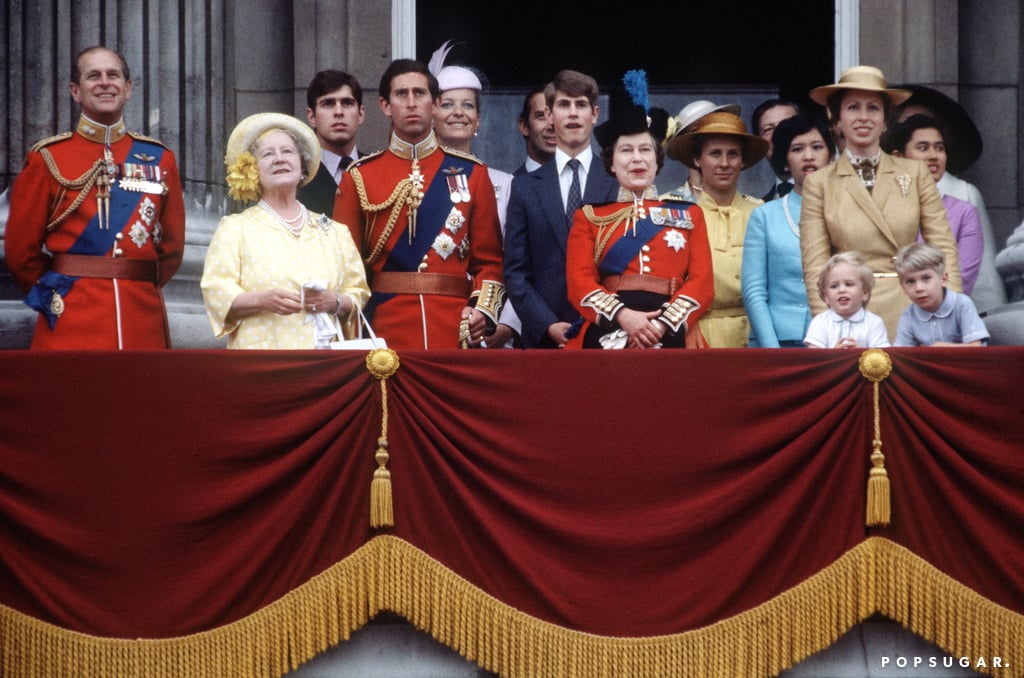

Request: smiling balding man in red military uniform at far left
left=4, top=47, right=185, bottom=349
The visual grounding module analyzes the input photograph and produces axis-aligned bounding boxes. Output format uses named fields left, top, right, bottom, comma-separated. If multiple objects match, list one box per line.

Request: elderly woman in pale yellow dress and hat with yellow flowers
left=201, top=113, right=370, bottom=348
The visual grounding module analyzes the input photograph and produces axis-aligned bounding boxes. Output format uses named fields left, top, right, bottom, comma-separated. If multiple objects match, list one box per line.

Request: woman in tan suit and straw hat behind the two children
left=800, top=66, right=961, bottom=338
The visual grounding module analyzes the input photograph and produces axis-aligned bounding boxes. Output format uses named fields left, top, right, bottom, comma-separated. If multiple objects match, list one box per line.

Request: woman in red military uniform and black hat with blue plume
left=566, top=71, right=714, bottom=348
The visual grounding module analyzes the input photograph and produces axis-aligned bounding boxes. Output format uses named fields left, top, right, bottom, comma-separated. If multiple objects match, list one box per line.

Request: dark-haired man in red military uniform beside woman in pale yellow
left=334, top=59, right=505, bottom=349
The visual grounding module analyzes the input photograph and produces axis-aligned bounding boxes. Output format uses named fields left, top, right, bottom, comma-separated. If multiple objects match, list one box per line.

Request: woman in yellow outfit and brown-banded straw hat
left=668, top=111, right=768, bottom=348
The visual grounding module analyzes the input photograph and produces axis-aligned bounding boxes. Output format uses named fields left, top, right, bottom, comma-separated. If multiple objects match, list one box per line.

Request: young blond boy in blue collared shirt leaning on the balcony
left=893, top=243, right=988, bottom=346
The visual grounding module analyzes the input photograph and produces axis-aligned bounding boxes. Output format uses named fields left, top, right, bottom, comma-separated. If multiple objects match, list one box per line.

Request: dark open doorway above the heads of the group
left=417, top=0, right=835, bottom=109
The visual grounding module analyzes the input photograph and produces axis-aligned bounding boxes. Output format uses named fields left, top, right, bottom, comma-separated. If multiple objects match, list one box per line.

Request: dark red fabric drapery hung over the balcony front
left=0, top=348, right=1024, bottom=675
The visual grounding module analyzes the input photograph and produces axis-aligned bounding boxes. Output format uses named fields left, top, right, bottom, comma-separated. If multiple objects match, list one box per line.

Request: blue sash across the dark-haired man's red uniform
left=366, top=150, right=477, bottom=320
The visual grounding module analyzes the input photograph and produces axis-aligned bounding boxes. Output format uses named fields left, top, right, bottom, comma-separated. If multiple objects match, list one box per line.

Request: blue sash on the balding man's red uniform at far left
left=25, top=139, right=164, bottom=330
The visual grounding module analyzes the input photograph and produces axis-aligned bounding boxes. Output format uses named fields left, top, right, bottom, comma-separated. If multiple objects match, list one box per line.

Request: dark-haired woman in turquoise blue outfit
left=741, top=114, right=836, bottom=348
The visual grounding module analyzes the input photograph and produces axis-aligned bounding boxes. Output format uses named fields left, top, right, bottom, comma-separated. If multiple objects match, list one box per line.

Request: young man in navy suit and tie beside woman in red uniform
left=505, top=71, right=618, bottom=348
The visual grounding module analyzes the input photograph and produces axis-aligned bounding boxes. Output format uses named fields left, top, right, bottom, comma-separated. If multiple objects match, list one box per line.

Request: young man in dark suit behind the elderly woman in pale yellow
left=298, top=70, right=367, bottom=216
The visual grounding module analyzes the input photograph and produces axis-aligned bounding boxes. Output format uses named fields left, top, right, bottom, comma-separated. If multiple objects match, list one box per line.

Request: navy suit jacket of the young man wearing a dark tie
left=505, top=153, right=618, bottom=348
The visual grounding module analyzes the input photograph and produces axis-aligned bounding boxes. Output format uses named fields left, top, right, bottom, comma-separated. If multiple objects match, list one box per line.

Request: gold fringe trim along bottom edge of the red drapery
left=0, top=536, right=1024, bottom=678
